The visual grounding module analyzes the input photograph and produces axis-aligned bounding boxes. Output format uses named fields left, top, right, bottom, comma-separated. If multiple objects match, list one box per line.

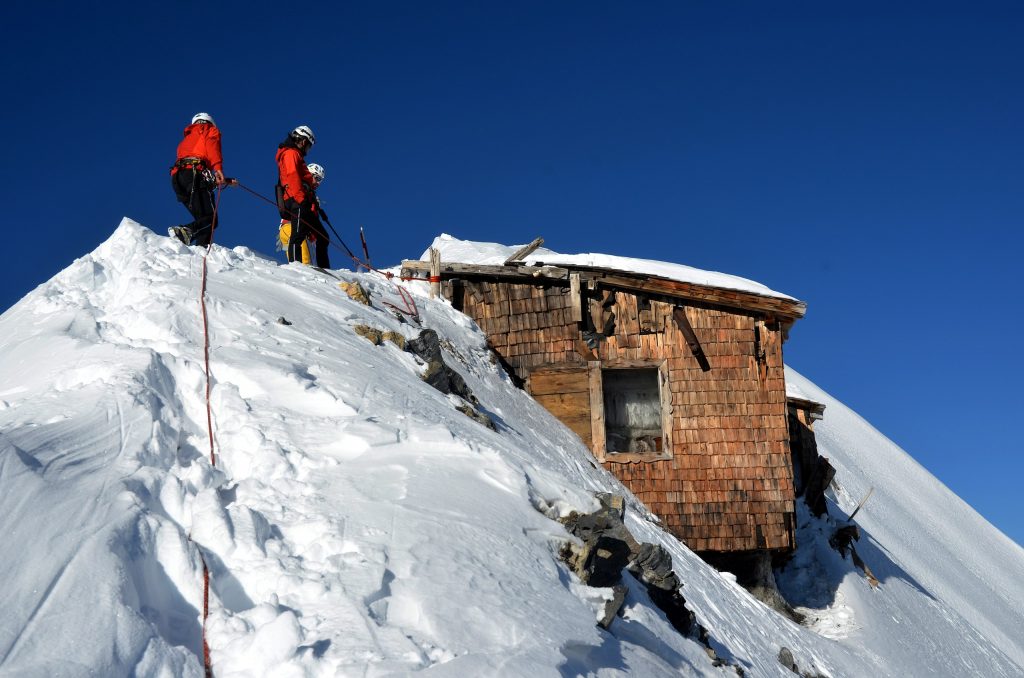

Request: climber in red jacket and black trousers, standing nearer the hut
left=276, top=125, right=331, bottom=268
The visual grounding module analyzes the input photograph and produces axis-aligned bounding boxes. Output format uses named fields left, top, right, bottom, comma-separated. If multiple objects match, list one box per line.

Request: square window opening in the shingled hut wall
left=601, top=368, right=665, bottom=454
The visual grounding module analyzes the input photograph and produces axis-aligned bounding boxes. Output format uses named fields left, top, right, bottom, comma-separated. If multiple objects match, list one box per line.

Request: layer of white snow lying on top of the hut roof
left=420, top=234, right=795, bottom=299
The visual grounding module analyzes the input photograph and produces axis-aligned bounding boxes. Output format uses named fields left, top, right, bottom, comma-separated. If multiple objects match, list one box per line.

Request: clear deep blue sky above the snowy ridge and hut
left=0, top=2, right=1024, bottom=543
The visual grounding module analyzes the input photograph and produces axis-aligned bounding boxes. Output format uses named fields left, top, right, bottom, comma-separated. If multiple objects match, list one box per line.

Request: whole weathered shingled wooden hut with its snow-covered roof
left=402, top=240, right=805, bottom=556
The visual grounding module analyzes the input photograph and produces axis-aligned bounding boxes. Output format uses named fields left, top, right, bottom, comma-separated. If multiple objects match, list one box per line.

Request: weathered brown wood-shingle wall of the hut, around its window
left=446, top=282, right=794, bottom=551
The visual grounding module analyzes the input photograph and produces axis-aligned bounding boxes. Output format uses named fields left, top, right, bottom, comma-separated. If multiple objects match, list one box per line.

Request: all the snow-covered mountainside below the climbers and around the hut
left=0, top=219, right=1024, bottom=677
